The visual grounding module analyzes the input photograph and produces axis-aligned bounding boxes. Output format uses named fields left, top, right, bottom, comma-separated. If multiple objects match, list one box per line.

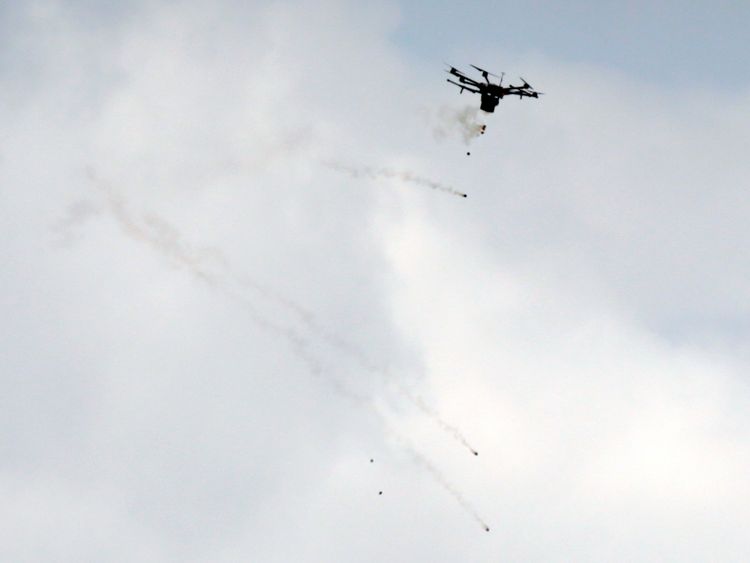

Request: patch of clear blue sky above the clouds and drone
left=394, top=0, right=750, bottom=90
